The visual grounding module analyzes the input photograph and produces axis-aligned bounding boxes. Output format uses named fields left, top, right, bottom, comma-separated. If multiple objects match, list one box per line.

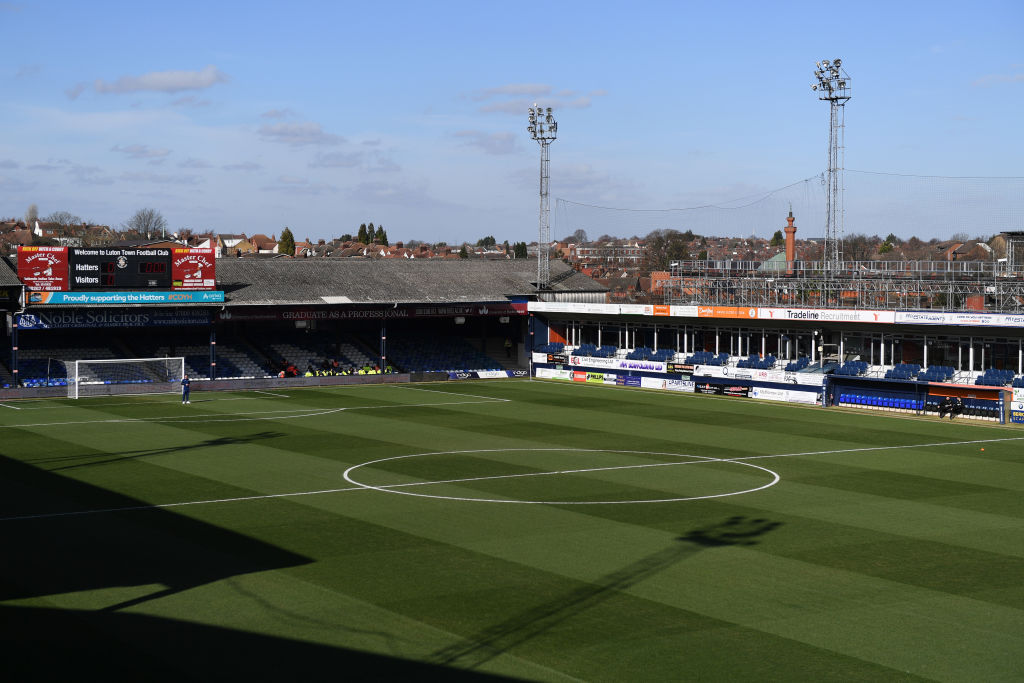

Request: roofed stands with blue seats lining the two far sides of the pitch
left=0, top=250, right=1024, bottom=423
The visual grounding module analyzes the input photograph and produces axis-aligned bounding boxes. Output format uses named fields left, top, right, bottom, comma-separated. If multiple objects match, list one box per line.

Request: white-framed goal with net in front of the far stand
left=68, top=356, right=185, bottom=398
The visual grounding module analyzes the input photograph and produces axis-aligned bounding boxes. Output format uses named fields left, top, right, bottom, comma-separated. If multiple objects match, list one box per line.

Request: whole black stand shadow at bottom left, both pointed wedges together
left=0, top=457, right=512, bottom=682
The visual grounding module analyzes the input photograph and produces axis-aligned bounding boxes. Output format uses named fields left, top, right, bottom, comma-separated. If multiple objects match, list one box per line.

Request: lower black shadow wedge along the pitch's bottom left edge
left=0, top=607, right=512, bottom=683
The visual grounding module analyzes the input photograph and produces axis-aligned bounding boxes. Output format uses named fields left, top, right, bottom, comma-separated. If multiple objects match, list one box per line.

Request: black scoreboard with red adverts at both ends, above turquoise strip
left=17, top=247, right=216, bottom=292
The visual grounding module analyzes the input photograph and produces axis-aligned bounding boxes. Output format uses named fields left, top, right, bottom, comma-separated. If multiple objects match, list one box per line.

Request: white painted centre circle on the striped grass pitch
left=342, top=449, right=780, bottom=505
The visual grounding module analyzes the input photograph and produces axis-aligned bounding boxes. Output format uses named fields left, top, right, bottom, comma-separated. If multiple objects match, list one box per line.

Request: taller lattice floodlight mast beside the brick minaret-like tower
left=811, top=59, right=850, bottom=275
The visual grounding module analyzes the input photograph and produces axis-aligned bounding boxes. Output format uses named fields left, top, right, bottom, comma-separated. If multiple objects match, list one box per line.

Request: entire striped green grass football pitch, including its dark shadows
left=0, top=380, right=1024, bottom=682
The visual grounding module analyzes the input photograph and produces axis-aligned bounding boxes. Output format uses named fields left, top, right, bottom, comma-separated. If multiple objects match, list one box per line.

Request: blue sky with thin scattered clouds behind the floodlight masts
left=0, top=0, right=1024, bottom=244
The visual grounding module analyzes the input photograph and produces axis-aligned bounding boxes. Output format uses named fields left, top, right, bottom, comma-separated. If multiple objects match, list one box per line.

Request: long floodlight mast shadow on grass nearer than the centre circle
left=429, top=516, right=781, bottom=670
